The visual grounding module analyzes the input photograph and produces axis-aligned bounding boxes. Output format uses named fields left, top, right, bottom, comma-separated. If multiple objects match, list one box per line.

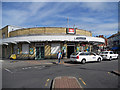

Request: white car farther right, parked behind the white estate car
left=100, top=51, right=118, bottom=61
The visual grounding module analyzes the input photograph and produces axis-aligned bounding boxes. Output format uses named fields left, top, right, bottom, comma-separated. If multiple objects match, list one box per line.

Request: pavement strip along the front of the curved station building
left=0, top=59, right=69, bottom=68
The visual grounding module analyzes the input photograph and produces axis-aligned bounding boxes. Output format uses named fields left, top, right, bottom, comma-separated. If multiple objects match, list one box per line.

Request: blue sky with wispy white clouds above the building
left=2, top=2, right=118, bottom=37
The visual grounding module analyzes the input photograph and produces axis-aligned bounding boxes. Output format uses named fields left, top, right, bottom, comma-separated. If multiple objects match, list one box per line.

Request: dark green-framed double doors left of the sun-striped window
left=35, top=46, right=44, bottom=60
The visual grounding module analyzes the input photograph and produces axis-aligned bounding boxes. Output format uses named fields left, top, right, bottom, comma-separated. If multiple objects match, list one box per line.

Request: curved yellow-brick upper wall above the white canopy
left=9, top=27, right=92, bottom=37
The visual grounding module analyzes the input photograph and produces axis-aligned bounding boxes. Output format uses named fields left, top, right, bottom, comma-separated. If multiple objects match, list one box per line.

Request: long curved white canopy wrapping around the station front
left=0, top=35, right=105, bottom=45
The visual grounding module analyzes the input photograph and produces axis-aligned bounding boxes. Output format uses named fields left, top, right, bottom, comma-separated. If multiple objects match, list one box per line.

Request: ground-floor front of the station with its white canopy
left=2, top=35, right=104, bottom=60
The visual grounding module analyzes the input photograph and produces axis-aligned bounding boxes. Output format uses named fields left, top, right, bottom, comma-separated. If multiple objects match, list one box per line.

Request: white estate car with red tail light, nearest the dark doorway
left=70, top=52, right=102, bottom=64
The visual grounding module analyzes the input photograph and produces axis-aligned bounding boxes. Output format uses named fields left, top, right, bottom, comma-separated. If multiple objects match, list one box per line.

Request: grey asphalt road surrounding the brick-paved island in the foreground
left=2, top=60, right=119, bottom=88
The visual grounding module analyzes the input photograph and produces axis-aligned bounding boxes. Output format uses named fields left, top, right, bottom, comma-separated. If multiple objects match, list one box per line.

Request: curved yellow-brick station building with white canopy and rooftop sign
left=0, top=25, right=105, bottom=60
